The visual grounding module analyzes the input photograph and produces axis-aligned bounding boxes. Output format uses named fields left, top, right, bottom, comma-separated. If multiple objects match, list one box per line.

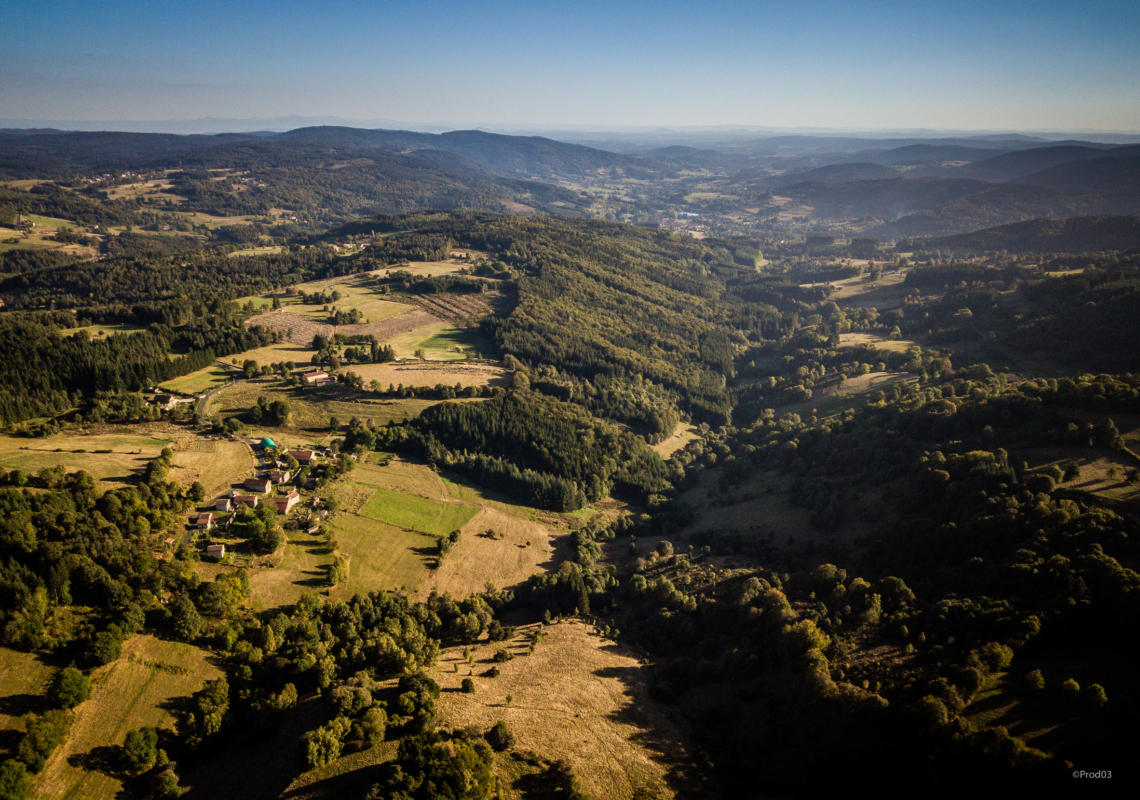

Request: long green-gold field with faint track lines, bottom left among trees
left=34, top=636, right=221, bottom=800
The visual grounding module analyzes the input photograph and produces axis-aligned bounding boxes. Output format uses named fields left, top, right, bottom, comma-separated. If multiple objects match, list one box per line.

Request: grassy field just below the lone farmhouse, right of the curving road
left=205, top=378, right=439, bottom=435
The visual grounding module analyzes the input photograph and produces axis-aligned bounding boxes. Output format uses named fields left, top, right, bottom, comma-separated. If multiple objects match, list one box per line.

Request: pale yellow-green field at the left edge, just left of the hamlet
left=0, top=433, right=171, bottom=485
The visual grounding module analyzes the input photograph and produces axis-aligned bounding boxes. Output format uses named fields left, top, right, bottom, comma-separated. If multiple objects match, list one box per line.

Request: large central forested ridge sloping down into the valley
left=337, top=214, right=782, bottom=431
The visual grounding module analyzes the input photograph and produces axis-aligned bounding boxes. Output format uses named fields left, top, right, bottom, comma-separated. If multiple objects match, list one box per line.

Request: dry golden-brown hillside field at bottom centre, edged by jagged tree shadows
left=432, top=622, right=700, bottom=800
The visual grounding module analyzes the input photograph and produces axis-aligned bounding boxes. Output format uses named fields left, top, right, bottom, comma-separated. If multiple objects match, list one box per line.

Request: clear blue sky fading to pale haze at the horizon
left=0, top=0, right=1140, bottom=132
